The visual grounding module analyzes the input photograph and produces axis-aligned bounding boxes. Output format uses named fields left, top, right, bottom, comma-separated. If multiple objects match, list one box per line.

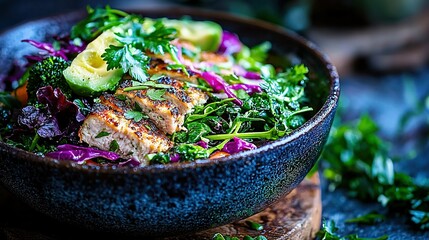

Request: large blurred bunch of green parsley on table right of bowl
left=322, top=115, right=429, bottom=229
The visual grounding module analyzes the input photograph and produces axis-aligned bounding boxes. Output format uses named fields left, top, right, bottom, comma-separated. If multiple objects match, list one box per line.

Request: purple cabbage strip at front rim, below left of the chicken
left=46, top=144, right=120, bottom=164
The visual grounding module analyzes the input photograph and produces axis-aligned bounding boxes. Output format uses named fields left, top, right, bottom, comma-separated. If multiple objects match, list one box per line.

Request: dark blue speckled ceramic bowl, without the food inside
left=0, top=8, right=339, bottom=236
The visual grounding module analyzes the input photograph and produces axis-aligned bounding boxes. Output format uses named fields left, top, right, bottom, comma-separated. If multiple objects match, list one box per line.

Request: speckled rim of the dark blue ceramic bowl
left=0, top=6, right=340, bottom=174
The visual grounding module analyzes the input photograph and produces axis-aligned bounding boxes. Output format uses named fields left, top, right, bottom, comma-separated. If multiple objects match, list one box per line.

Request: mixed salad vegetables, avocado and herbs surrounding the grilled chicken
left=0, top=6, right=313, bottom=167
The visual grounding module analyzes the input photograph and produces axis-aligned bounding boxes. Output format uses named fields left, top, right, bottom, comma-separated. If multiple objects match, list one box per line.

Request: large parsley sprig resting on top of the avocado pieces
left=101, top=19, right=187, bottom=82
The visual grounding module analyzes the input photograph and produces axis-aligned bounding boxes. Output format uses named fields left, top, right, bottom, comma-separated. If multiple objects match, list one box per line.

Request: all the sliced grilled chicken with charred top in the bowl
left=79, top=61, right=208, bottom=164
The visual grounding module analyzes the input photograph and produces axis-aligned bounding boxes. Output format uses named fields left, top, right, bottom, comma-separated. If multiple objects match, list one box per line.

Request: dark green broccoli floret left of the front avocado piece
left=27, top=57, right=73, bottom=103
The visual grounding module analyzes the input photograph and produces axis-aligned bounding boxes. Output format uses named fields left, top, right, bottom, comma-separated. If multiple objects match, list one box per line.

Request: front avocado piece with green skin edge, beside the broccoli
left=63, top=30, right=124, bottom=97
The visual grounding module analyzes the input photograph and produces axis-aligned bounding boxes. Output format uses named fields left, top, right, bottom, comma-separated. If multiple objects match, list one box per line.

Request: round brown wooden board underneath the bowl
left=169, top=173, right=322, bottom=240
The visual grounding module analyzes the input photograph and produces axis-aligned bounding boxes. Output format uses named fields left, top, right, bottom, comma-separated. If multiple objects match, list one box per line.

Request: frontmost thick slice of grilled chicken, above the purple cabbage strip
left=79, top=94, right=173, bottom=165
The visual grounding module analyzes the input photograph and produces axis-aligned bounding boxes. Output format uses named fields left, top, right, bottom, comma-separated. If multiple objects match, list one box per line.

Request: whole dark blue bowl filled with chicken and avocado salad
left=0, top=7, right=339, bottom=236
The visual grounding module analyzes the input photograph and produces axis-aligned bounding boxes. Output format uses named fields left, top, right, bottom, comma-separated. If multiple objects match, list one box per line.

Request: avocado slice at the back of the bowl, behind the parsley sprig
left=162, top=18, right=222, bottom=51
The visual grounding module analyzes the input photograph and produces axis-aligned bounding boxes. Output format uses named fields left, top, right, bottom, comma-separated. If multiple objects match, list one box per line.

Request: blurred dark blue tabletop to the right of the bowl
left=322, top=67, right=429, bottom=239
